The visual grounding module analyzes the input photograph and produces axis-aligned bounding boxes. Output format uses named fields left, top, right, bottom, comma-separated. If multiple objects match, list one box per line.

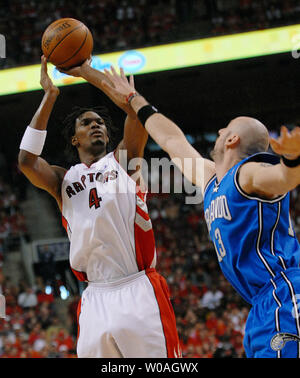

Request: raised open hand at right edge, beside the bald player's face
left=270, top=126, right=300, bottom=159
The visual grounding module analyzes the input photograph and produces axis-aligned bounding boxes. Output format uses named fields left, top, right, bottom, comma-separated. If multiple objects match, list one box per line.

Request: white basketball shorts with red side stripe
left=77, top=269, right=181, bottom=358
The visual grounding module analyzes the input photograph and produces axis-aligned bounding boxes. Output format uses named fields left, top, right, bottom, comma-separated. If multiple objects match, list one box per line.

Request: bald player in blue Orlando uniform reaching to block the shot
left=85, top=69, right=300, bottom=358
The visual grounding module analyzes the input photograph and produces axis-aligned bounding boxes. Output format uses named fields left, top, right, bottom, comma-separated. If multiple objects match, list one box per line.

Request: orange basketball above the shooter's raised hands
left=42, top=18, right=93, bottom=69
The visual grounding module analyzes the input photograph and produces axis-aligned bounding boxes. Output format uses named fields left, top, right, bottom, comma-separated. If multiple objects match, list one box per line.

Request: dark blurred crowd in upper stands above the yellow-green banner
left=0, top=0, right=300, bottom=67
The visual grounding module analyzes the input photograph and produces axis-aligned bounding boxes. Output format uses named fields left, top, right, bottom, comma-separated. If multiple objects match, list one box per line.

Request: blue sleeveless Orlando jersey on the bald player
left=204, top=153, right=300, bottom=303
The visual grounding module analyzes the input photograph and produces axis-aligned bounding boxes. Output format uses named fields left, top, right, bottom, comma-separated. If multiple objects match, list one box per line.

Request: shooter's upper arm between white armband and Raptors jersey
left=18, top=150, right=67, bottom=206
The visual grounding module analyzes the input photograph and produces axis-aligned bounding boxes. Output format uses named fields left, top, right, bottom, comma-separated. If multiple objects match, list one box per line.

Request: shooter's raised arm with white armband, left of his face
left=18, top=57, right=66, bottom=210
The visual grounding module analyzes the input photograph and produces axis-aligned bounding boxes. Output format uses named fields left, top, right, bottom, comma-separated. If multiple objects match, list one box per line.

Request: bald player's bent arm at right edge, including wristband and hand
left=239, top=126, right=300, bottom=199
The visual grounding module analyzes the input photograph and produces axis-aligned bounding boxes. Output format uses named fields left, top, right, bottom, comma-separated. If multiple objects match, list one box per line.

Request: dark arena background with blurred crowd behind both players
left=0, top=0, right=300, bottom=358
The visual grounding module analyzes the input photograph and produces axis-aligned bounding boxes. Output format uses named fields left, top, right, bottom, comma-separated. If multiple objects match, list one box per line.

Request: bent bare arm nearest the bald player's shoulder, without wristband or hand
left=238, top=162, right=300, bottom=199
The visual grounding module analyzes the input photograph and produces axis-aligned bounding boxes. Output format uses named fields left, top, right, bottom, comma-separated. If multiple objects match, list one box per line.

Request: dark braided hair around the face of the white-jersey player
left=62, top=105, right=116, bottom=161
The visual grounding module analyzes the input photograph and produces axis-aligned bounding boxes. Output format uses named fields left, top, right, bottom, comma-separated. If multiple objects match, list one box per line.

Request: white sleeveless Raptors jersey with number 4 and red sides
left=62, top=152, right=156, bottom=282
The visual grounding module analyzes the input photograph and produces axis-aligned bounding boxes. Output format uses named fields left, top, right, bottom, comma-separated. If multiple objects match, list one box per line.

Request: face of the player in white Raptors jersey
left=72, top=111, right=109, bottom=150
